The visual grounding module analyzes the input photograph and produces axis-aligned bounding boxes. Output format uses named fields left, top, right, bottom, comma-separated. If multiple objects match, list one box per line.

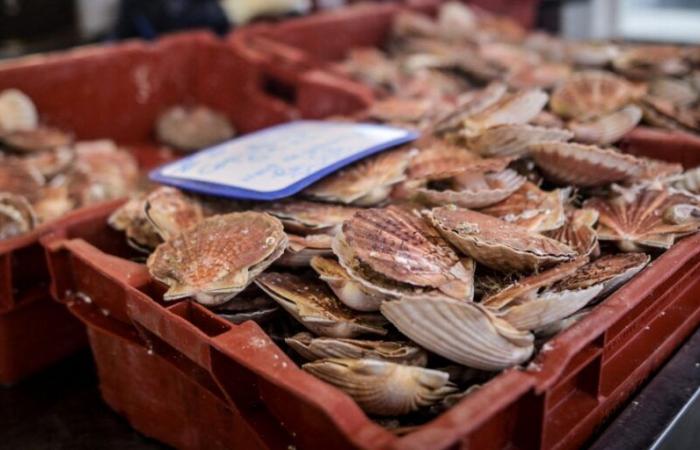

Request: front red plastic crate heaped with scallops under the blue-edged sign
left=43, top=127, right=700, bottom=449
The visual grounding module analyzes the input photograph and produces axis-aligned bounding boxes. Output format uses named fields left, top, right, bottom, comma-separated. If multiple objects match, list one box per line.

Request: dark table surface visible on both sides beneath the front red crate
left=0, top=330, right=700, bottom=450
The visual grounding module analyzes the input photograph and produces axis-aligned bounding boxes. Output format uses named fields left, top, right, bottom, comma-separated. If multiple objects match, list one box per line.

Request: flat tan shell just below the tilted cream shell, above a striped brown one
left=465, top=124, right=574, bottom=157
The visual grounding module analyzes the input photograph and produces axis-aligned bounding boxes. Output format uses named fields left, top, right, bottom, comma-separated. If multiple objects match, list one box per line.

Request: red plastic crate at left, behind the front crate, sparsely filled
left=0, top=32, right=360, bottom=384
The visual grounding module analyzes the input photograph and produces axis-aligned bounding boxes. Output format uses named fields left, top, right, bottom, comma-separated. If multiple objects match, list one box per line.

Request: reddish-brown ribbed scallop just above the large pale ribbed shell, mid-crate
left=333, top=206, right=473, bottom=299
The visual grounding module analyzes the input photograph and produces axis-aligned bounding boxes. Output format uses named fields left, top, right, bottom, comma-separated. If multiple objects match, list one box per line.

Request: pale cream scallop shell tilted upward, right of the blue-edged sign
left=461, top=89, right=549, bottom=137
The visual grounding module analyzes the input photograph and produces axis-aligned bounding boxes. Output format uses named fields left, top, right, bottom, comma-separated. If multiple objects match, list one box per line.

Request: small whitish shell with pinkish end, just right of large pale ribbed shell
left=499, top=285, right=603, bottom=330
